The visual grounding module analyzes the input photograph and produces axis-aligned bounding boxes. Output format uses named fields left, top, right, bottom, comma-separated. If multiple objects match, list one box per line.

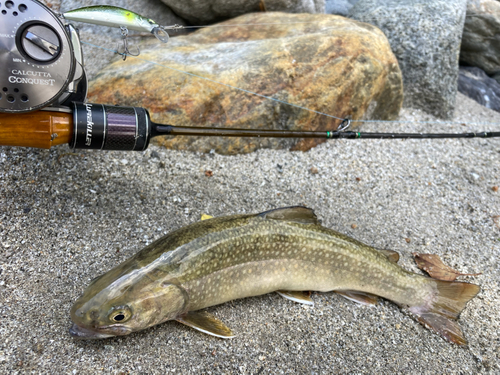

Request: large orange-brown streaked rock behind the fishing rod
left=90, top=13, right=403, bottom=154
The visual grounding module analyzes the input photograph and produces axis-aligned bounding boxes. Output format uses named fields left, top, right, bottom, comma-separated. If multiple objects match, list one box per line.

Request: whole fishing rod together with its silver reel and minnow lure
left=0, top=0, right=500, bottom=151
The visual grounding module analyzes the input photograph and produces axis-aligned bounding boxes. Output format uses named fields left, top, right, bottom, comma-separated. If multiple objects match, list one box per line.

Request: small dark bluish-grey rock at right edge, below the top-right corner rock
left=458, top=66, right=500, bottom=112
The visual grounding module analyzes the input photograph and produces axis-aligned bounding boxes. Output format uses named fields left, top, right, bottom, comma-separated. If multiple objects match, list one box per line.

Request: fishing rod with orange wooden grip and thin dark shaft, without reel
left=0, top=103, right=500, bottom=151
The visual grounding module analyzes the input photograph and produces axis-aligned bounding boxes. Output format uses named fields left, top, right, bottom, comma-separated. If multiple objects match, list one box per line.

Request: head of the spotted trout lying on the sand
left=69, top=270, right=188, bottom=339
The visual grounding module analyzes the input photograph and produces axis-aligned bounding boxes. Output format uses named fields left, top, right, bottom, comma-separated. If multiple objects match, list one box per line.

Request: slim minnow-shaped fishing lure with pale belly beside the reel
left=62, top=5, right=182, bottom=43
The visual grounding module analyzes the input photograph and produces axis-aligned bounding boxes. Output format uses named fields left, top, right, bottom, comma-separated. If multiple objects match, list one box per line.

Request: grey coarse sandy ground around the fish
left=0, top=90, right=500, bottom=374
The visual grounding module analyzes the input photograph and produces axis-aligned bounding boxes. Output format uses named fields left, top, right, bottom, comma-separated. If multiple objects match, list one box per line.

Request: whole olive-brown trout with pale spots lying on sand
left=69, top=206, right=480, bottom=345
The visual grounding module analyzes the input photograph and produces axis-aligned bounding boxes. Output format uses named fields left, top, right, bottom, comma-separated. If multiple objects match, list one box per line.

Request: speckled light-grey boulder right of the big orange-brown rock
left=349, top=0, right=467, bottom=119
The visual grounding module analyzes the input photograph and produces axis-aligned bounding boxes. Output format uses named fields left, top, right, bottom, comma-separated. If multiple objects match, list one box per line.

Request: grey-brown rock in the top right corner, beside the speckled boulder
left=460, top=0, right=500, bottom=75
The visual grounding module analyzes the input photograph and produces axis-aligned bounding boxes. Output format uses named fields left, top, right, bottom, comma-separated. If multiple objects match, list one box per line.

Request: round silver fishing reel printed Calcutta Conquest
left=0, top=0, right=87, bottom=113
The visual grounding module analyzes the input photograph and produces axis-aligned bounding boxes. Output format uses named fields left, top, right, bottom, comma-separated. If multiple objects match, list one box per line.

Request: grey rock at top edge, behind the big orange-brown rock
left=158, top=0, right=325, bottom=25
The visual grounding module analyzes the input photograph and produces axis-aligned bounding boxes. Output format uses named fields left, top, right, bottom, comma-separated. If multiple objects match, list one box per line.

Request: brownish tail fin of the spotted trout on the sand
left=410, top=279, right=480, bottom=345
